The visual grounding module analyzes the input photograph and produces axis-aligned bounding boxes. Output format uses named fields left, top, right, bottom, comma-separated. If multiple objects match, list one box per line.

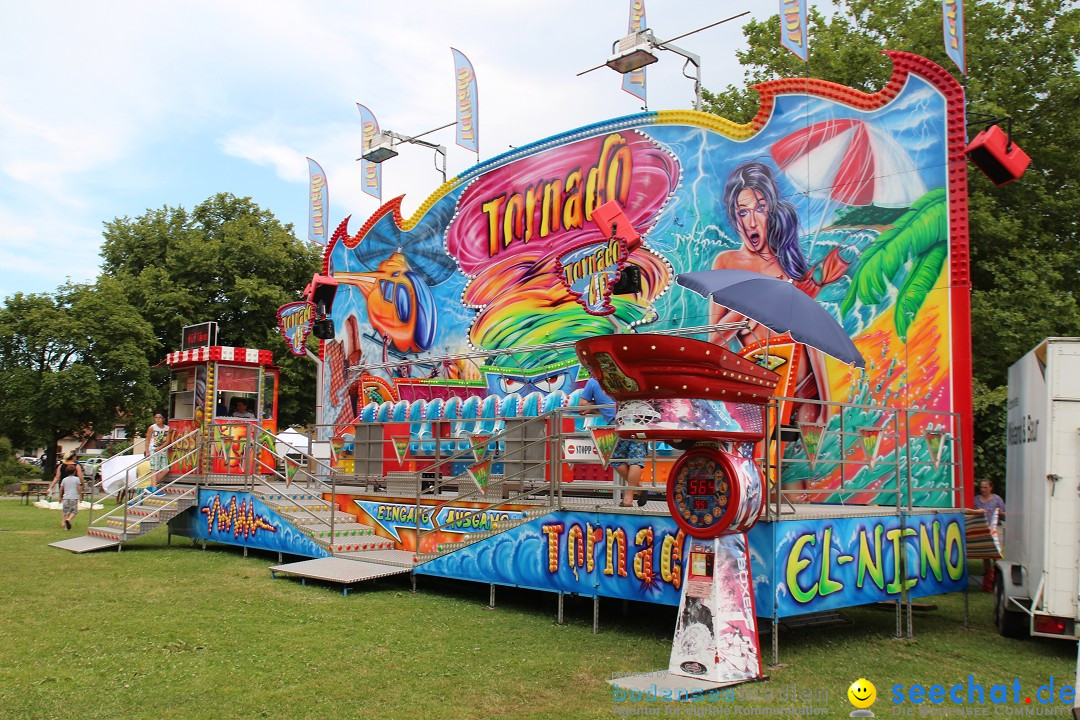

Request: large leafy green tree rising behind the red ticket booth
left=102, top=193, right=321, bottom=424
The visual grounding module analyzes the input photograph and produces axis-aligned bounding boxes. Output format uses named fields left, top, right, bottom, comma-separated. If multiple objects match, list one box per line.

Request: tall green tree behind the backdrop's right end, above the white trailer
left=704, top=0, right=1080, bottom=478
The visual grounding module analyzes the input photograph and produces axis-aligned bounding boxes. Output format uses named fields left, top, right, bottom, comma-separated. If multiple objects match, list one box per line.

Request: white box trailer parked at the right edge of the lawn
left=994, top=338, right=1080, bottom=639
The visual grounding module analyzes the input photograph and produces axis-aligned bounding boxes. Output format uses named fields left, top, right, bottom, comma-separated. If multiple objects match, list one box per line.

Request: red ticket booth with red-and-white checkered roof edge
left=165, top=323, right=279, bottom=475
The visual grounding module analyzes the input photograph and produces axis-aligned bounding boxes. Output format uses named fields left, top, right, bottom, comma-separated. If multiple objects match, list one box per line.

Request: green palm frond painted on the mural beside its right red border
left=840, top=188, right=948, bottom=338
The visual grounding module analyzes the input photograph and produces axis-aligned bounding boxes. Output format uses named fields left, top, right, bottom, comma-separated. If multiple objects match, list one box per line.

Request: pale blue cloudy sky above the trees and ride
left=0, top=0, right=794, bottom=298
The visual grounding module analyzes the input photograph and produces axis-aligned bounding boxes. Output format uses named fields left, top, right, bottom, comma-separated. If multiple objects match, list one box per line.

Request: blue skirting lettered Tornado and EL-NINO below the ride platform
left=416, top=512, right=967, bottom=617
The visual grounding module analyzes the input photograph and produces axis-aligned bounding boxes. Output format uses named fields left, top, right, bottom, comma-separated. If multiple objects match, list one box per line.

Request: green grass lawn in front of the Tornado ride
left=0, top=500, right=1076, bottom=720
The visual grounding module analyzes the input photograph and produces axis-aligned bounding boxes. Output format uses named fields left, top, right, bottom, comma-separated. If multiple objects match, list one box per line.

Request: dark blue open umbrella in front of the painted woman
left=675, top=270, right=866, bottom=367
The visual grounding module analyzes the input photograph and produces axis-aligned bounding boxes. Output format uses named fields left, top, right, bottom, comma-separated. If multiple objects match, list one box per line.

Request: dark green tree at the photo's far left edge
left=0, top=279, right=159, bottom=475
